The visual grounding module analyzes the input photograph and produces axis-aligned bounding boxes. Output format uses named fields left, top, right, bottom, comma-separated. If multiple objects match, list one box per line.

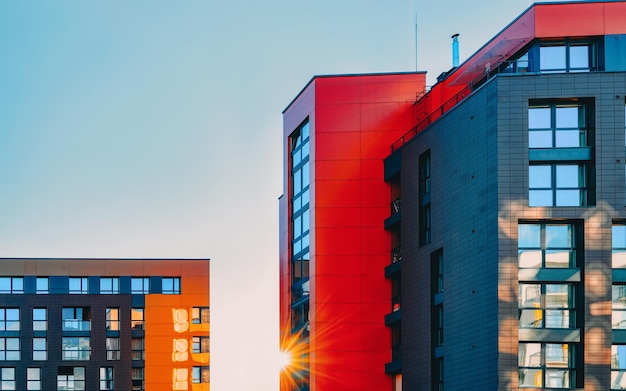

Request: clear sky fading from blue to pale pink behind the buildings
left=0, top=0, right=576, bottom=391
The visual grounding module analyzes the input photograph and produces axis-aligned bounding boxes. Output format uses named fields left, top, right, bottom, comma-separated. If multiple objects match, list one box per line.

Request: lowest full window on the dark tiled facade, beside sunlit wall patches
left=518, top=342, right=576, bottom=388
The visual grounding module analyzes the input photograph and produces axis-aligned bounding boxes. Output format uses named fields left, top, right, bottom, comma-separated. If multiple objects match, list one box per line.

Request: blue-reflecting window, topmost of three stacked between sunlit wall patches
left=518, top=223, right=577, bottom=268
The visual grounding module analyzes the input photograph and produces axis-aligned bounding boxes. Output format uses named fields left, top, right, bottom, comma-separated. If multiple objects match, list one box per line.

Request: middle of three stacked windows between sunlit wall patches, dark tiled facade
left=518, top=283, right=576, bottom=329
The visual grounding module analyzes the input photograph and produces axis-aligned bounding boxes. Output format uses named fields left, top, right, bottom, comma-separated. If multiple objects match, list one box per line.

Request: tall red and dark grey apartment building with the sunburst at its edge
left=280, top=1, right=626, bottom=391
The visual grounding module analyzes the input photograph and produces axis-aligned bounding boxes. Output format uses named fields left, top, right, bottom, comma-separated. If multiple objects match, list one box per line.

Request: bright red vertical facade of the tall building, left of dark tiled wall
left=281, top=73, right=425, bottom=391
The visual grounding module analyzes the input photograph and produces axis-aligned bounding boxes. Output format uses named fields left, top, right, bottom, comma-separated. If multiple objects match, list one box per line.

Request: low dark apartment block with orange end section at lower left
left=0, top=258, right=210, bottom=391
